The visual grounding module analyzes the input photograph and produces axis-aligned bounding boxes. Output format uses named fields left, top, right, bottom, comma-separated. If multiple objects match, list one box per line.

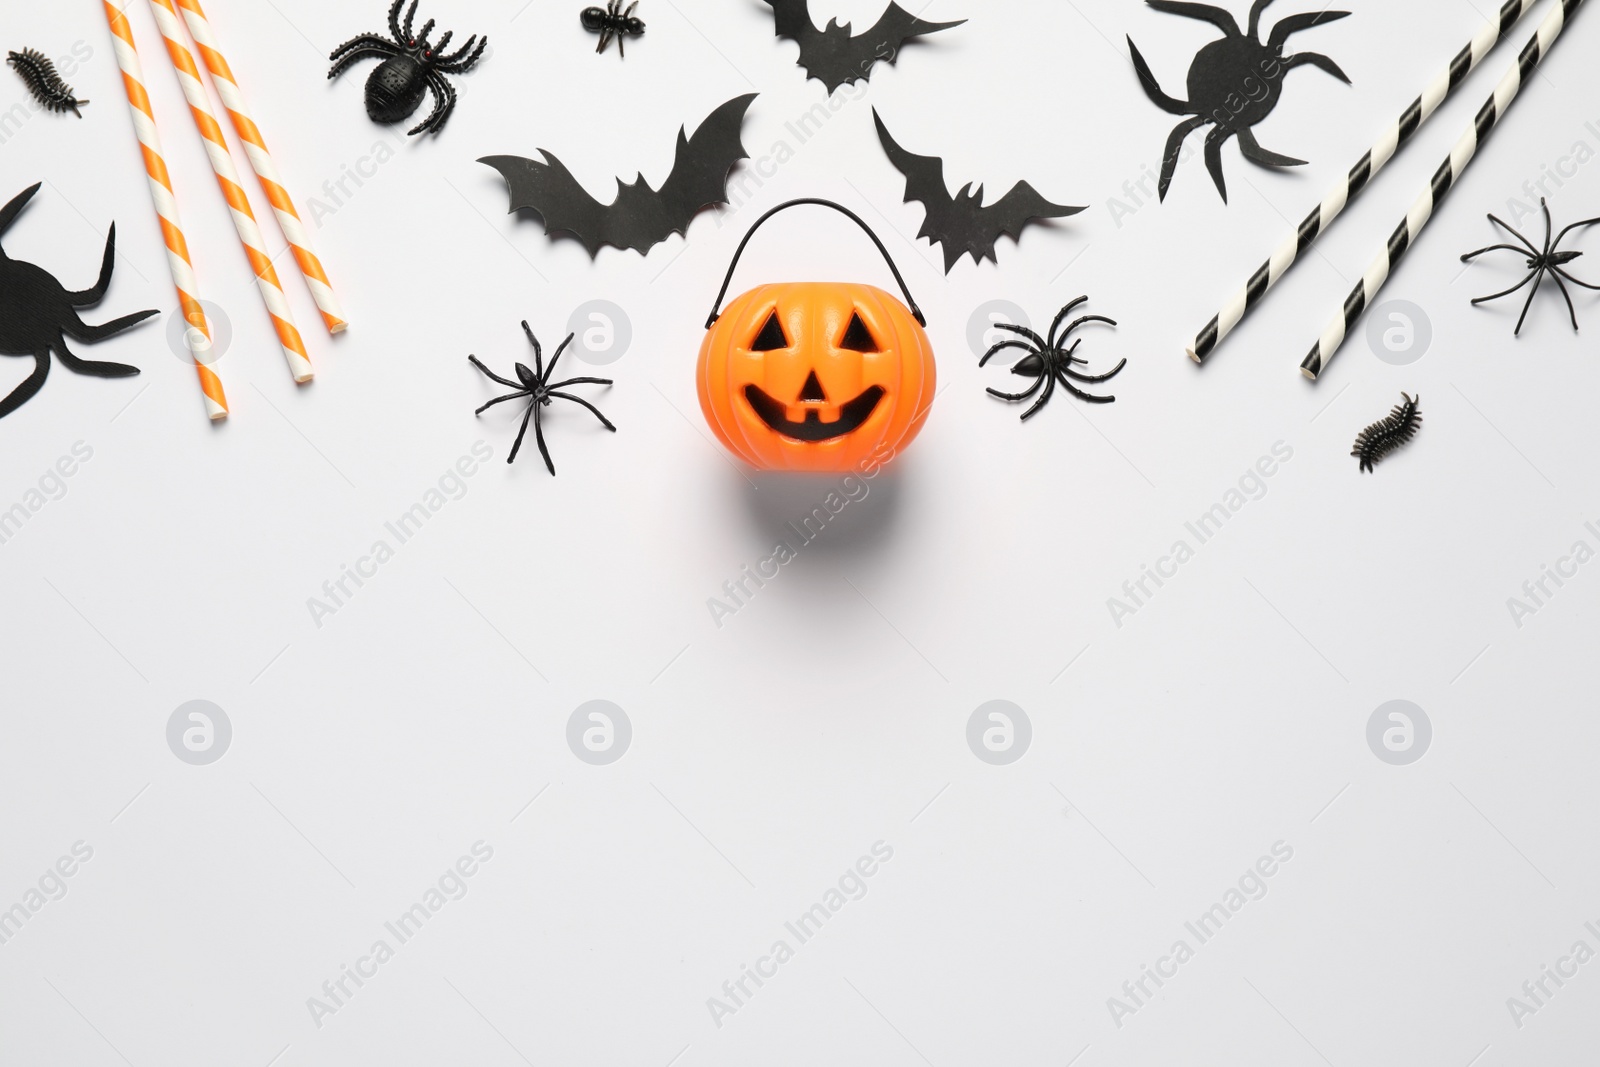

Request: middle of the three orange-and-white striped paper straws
left=150, top=0, right=315, bottom=382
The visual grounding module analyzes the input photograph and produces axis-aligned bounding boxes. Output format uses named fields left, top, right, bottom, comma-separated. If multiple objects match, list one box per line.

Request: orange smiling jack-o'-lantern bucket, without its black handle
left=698, top=282, right=934, bottom=470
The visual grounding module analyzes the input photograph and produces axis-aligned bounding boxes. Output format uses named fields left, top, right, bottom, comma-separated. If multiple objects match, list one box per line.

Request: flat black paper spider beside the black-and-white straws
left=1128, top=0, right=1350, bottom=203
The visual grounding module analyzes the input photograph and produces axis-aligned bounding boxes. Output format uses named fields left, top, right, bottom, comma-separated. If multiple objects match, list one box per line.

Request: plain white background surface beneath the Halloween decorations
left=0, top=0, right=1600, bottom=1067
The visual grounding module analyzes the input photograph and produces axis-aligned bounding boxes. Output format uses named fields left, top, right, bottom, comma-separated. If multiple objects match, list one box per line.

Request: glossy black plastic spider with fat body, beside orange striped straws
left=328, top=0, right=490, bottom=136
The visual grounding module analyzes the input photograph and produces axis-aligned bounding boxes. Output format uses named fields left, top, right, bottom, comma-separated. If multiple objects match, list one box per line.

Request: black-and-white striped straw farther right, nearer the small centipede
left=1301, top=0, right=1584, bottom=379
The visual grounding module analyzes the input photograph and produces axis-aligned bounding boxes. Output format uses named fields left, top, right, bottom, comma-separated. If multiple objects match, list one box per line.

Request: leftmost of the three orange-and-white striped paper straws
left=104, top=0, right=227, bottom=422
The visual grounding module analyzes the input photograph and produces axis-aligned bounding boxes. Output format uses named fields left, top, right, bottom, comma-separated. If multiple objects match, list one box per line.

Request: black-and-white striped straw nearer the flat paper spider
left=1189, top=0, right=1538, bottom=363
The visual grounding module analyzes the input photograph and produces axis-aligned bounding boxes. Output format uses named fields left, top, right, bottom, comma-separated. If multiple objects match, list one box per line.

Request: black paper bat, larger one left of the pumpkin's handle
left=478, top=93, right=755, bottom=258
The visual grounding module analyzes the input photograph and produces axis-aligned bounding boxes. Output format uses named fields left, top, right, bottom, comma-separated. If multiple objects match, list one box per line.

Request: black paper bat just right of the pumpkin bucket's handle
left=872, top=107, right=1083, bottom=274
